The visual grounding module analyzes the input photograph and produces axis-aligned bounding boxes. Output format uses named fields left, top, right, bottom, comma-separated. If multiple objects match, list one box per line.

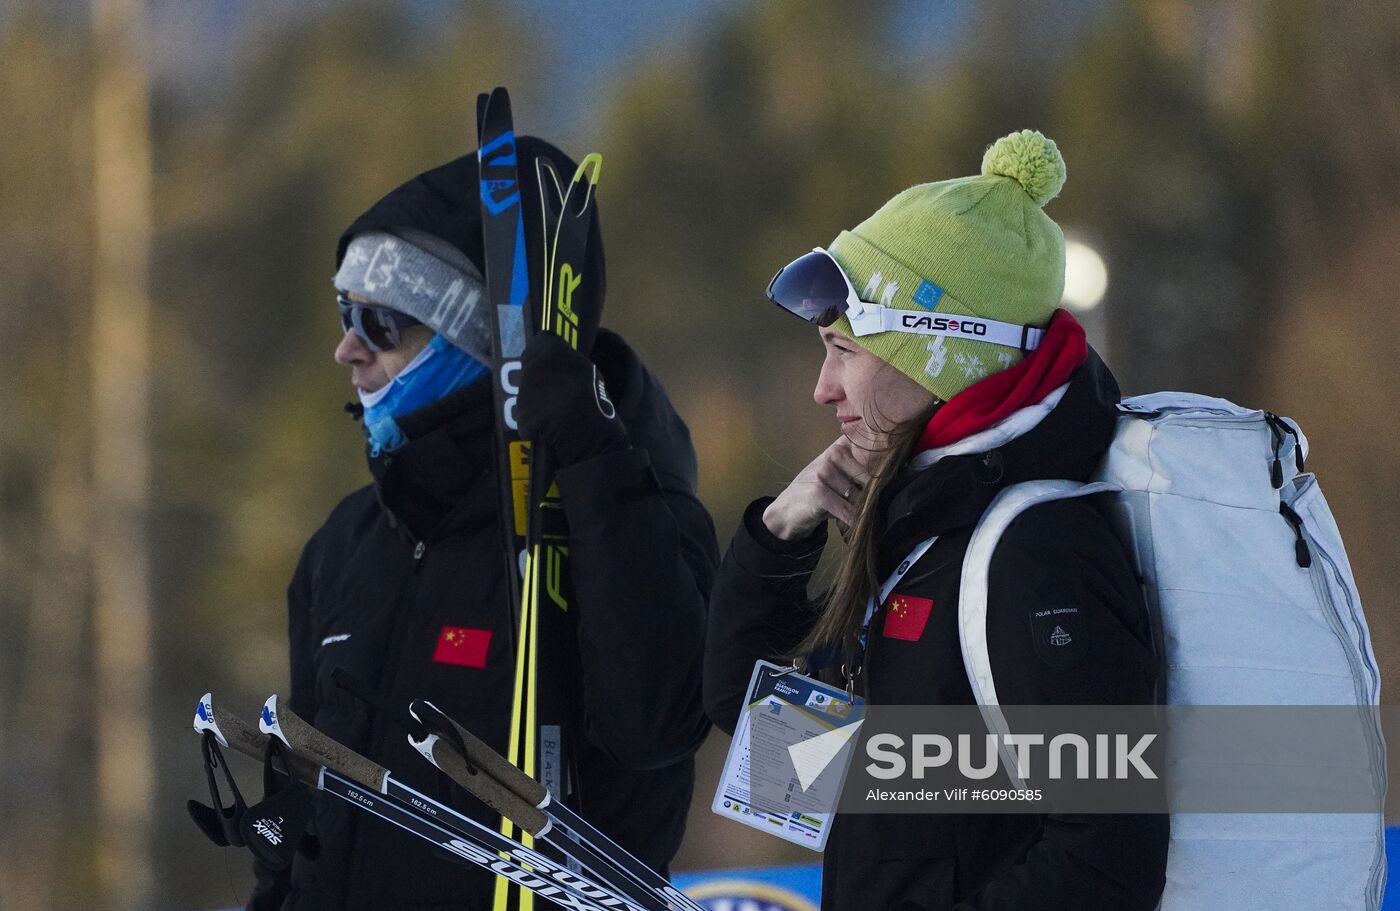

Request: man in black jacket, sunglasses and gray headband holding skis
left=249, top=137, right=718, bottom=911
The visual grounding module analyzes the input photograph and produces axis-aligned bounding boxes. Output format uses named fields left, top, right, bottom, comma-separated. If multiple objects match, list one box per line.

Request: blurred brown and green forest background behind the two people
left=0, top=0, right=1400, bottom=911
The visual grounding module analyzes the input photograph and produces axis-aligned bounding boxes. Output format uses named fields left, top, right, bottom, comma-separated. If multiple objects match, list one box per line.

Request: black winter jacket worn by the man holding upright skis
left=259, top=332, right=718, bottom=911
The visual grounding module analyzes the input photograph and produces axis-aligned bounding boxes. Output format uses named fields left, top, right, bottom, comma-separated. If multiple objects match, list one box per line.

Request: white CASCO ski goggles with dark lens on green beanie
left=767, top=246, right=1044, bottom=351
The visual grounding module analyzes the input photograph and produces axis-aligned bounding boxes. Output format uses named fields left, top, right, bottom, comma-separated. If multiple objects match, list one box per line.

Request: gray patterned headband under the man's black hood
left=335, top=229, right=491, bottom=362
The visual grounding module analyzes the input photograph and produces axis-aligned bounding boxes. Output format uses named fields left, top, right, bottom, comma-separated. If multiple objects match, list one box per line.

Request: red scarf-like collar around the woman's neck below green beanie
left=918, top=309, right=1089, bottom=452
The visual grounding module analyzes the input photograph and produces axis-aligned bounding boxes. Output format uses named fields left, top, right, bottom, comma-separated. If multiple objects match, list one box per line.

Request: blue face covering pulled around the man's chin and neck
left=360, top=334, right=486, bottom=456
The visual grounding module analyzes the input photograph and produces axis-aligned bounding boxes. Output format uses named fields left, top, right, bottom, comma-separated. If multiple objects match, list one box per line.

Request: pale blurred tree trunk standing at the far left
left=91, top=0, right=154, bottom=911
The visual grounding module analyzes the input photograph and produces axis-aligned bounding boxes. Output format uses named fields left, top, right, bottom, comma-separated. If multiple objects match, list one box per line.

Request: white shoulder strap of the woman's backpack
left=958, top=480, right=1119, bottom=788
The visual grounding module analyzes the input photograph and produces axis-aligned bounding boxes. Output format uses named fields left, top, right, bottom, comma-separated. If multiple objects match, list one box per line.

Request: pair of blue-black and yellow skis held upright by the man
left=477, top=88, right=602, bottom=911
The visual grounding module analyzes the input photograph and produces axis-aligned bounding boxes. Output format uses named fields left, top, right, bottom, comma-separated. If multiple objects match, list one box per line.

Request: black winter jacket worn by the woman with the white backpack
left=704, top=353, right=1168, bottom=911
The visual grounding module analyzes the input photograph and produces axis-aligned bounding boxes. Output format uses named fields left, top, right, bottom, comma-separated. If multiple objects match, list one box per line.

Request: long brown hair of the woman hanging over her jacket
left=792, top=399, right=942, bottom=673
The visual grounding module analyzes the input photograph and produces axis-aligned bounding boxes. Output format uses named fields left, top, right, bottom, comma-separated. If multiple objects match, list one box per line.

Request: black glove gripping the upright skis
left=515, top=332, right=627, bottom=467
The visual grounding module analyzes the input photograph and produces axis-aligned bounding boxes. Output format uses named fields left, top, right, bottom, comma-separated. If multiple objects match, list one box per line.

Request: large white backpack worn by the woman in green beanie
left=959, top=392, right=1386, bottom=911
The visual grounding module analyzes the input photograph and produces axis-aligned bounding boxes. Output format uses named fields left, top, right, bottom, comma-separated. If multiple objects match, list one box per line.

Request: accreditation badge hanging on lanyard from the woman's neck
left=710, top=661, right=865, bottom=851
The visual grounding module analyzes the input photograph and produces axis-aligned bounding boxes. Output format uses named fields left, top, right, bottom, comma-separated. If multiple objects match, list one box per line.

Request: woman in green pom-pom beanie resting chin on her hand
left=704, top=130, right=1168, bottom=911
